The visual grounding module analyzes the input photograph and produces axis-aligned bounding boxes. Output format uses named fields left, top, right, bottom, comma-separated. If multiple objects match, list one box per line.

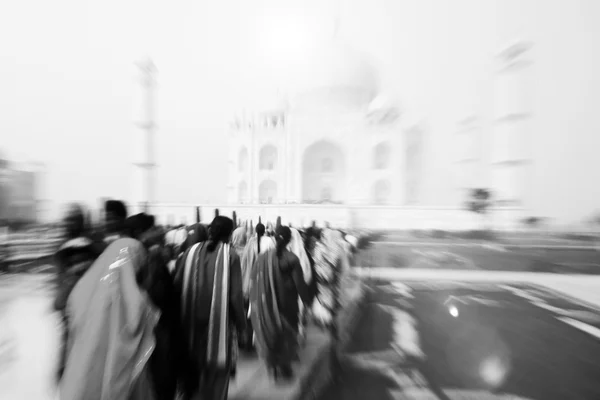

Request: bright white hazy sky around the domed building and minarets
left=0, top=0, right=600, bottom=222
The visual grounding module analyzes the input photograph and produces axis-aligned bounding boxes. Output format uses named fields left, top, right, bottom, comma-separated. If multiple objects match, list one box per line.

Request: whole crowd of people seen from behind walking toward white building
left=54, top=200, right=356, bottom=400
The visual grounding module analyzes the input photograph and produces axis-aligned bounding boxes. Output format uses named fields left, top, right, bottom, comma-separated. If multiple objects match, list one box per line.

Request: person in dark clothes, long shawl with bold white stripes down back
left=175, top=216, right=246, bottom=400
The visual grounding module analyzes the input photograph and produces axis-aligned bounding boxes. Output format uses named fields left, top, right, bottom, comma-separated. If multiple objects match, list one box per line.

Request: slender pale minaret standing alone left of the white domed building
left=130, top=58, right=157, bottom=213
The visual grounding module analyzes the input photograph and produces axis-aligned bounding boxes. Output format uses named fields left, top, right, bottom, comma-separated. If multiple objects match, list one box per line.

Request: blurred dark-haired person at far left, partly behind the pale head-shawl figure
left=54, top=204, right=102, bottom=380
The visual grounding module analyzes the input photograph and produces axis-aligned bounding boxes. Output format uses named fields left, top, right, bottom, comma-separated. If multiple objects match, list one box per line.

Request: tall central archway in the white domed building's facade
left=302, top=140, right=346, bottom=203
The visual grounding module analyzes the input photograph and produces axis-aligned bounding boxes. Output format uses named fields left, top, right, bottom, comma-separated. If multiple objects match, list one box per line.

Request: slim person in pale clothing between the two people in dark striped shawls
left=241, top=220, right=275, bottom=351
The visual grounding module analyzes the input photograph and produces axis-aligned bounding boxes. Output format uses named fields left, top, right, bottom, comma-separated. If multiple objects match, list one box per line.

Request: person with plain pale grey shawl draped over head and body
left=59, top=238, right=159, bottom=400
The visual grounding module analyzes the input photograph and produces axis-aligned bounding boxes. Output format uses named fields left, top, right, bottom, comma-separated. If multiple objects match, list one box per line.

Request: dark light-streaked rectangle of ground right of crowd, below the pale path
left=321, top=281, right=600, bottom=400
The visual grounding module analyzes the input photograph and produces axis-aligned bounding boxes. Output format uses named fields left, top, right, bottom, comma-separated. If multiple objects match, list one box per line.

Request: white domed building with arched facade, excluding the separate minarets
left=228, top=38, right=423, bottom=205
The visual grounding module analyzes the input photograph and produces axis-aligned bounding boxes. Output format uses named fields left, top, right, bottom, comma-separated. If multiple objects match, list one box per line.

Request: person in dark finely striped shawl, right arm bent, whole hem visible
left=250, top=226, right=310, bottom=379
